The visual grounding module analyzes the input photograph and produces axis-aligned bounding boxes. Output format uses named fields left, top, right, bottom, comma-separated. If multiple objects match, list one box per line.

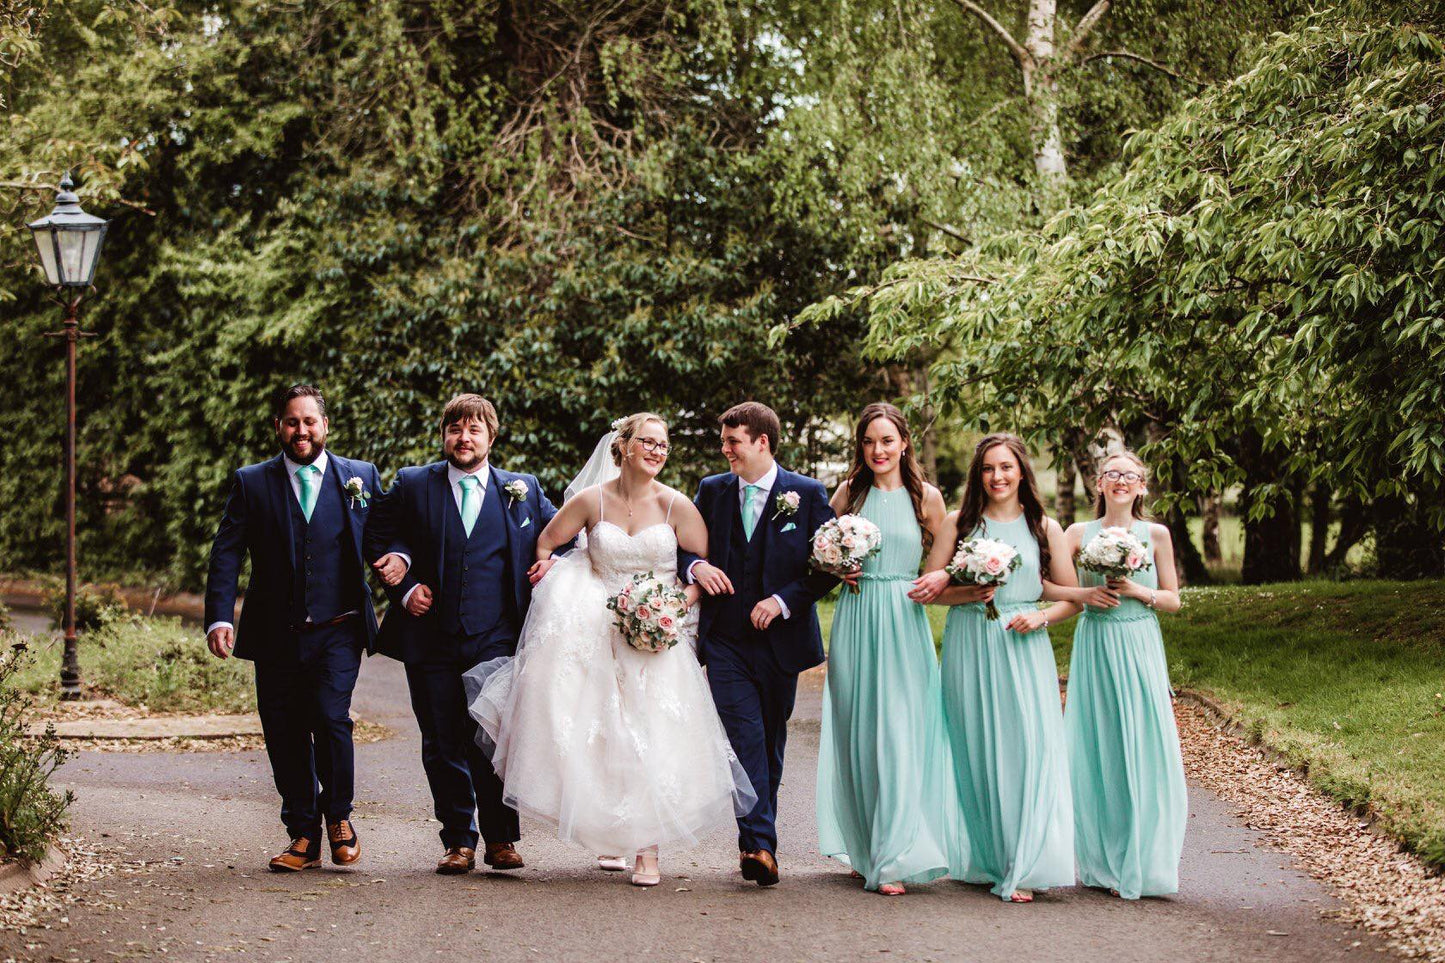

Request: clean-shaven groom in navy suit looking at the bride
left=679, top=402, right=837, bottom=886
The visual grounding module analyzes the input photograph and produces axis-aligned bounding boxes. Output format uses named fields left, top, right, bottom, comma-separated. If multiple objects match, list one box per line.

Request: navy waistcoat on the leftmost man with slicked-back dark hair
left=288, top=467, right=363, bottom=625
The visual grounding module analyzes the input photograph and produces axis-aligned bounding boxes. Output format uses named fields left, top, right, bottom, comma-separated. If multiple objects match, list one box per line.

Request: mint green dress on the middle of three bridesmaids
left=942, top=516, right=1074, bottom=899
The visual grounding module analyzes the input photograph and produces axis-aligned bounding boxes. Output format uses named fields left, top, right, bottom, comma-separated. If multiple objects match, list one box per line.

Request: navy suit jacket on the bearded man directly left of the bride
left=364, top=461, right=556, bottom=662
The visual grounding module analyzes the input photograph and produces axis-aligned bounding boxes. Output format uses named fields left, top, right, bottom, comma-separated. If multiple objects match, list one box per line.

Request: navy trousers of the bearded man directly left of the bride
left=406, top=635, right=522, bottom=849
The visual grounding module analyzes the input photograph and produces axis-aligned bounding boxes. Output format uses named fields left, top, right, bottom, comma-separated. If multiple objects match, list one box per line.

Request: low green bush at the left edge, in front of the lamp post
left=0, top=633, right=74, bottom=862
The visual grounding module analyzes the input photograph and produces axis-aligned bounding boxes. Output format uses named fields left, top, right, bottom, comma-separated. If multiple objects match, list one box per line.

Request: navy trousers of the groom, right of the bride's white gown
left=708, top=630, right=798, bottom=853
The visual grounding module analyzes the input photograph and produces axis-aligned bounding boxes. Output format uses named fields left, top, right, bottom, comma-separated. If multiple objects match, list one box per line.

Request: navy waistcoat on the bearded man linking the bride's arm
left=438, top=484, right=514, bottom=636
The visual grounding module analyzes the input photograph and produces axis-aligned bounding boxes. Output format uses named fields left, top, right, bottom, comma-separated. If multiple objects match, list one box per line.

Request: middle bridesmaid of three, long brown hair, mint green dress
left=919, top=434, right=1078, bottom=902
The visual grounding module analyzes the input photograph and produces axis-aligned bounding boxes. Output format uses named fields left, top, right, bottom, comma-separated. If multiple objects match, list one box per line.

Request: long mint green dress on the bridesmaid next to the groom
left=818, top=489, right=958, bottom=889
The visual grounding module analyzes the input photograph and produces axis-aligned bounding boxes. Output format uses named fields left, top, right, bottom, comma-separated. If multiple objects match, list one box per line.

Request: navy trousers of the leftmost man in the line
left=256, top=616, right=364, bottom=840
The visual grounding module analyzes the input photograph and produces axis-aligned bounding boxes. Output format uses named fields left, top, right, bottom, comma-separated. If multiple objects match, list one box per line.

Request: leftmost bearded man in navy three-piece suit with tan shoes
left=205, top=385, right=380, bottom=872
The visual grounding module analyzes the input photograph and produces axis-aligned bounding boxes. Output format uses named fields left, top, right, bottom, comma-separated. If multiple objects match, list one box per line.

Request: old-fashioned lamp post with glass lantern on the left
left=29, top=174, right=107, bottom=698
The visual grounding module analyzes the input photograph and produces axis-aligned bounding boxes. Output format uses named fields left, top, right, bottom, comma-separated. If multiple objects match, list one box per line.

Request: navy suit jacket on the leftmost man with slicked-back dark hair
left=205, top=451, right=381, bottom=659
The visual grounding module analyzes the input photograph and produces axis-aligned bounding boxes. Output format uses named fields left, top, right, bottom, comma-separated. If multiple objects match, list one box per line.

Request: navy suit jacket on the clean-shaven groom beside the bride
left=678, top=466, right=838, bottom=672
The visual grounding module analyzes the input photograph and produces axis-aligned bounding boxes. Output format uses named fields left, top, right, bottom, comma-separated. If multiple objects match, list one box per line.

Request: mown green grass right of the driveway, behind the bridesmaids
left=819, top=581, right=1445, bottom=868
